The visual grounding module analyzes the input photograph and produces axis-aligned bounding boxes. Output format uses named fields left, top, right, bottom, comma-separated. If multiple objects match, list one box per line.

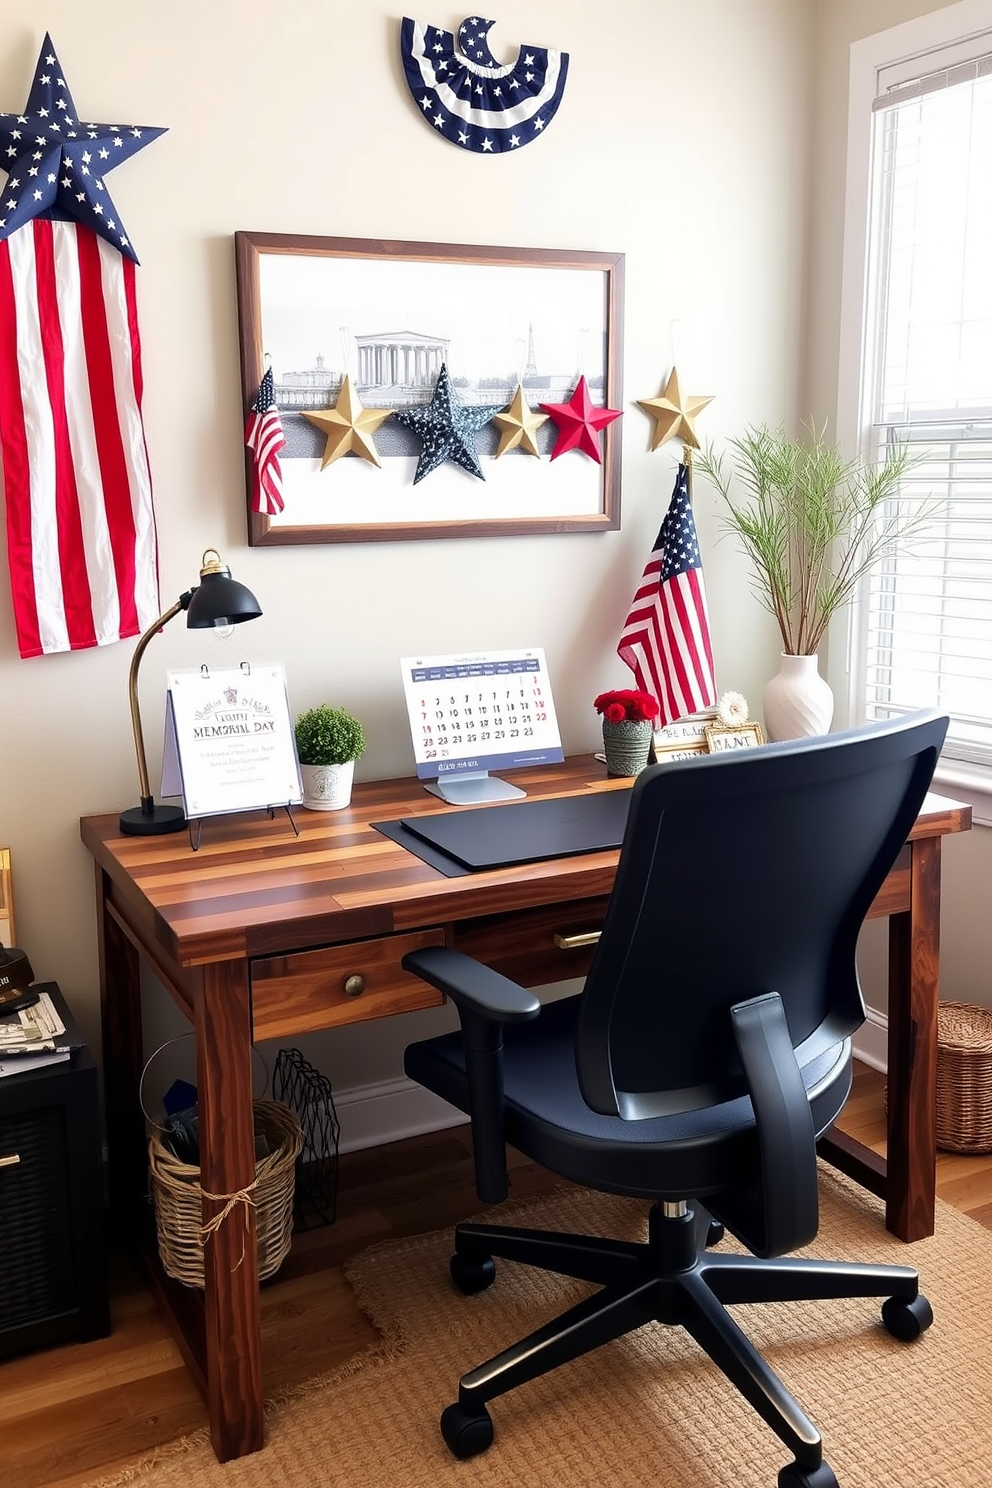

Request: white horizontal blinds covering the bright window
left=860, top=36, right=992, bottom=765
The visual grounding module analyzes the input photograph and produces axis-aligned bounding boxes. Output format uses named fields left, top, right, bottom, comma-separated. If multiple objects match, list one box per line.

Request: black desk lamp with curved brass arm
left=120, top=548, right=262, bottom=836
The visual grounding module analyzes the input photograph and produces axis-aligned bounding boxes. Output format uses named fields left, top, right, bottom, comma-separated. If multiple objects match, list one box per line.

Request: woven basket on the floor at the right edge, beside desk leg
left=937, top=1003, right=992, bottom=1152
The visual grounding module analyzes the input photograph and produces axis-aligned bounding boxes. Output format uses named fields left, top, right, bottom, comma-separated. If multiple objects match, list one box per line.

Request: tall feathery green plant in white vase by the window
left=695, top=423, right=931, bottom=740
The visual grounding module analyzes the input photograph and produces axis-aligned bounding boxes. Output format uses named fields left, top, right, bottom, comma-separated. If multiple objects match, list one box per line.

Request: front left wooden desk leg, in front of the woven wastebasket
left=195, top=961, right=265, bottom=1463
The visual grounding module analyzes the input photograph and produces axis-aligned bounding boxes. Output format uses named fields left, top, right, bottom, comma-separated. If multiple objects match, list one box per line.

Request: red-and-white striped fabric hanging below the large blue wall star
left=0, top=217, right=159, bottom=656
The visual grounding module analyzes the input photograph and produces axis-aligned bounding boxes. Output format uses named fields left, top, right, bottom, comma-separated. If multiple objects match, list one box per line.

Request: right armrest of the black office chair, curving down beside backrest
left=730, top=992, right=819, bottom=1256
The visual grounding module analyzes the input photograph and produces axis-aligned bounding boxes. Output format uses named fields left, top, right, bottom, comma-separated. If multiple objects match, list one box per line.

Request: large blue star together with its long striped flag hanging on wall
left=0, top=36, right=164, bottom=658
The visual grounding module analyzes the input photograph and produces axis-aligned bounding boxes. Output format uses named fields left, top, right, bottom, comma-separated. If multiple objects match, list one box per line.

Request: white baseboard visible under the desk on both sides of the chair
left=335, top=1007, right=888, bottom=1152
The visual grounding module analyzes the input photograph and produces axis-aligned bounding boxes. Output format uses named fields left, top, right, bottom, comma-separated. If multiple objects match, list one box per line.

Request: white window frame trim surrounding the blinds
left=827, top=0, right=992, bottom=826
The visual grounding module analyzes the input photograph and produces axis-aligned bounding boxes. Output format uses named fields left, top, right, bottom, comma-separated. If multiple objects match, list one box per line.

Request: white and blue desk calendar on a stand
left=400, top=646, right=565, bottom=805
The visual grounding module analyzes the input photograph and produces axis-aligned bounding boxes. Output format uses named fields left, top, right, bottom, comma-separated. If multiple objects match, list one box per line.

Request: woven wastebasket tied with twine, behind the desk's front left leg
left=149, top=1101, right=300, bottom=1287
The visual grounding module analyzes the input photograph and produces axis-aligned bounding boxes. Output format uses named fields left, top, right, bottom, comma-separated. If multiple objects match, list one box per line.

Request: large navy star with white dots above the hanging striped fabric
left=0, top=34, right=165, bottom=263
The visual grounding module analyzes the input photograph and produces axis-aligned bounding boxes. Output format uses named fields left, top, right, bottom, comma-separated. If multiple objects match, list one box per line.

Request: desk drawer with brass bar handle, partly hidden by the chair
left=452, top=894, right=610, bottom=987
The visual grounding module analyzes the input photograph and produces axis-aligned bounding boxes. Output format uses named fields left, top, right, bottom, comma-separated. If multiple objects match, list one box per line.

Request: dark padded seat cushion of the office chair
left=405, top=994, right=851, bottom=1199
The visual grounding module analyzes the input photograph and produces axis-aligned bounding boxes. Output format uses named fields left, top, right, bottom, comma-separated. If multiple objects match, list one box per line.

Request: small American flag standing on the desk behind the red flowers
left=617, top=464, right=717, bottom=728
